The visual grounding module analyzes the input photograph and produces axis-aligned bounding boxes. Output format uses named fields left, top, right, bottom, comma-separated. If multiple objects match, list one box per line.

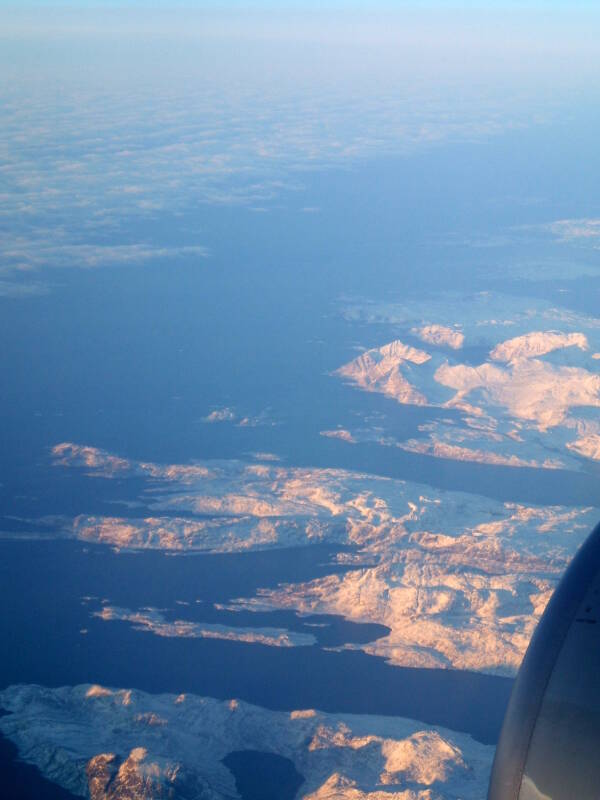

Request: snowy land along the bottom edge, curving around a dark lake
left=0, top=685, right=494, bottom=800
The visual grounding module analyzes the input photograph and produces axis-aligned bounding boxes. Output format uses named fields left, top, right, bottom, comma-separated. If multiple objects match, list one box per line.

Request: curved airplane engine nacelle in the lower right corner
left=488, top=525, right=600, bottom=800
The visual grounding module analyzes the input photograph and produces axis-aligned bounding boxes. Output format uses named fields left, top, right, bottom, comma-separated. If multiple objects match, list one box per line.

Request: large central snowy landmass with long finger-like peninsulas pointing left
left=48, top=444, right=597, bottom=674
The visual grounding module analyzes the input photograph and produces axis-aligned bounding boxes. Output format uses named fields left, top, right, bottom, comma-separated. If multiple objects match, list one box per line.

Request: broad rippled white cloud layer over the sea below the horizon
left=0, top=18, right=555, bottom=300
